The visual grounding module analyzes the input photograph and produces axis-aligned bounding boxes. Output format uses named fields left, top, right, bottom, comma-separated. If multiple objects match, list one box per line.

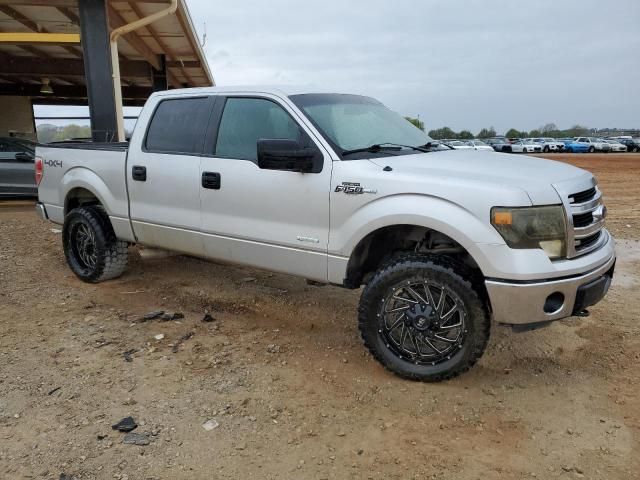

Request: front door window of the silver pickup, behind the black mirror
left=215, top=97, right=303, bottom=162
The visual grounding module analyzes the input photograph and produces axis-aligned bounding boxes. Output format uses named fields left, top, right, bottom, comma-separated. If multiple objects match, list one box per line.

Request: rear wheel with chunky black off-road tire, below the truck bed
left=62, top=205, right=129, bottom=283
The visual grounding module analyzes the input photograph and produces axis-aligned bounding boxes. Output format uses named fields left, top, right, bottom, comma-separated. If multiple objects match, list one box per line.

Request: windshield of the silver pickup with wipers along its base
left=289, top=93, right=433, bottom=158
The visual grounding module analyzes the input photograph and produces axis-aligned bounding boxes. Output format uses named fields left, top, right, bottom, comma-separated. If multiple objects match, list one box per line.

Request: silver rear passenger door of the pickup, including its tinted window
left=126, top=96, right=213, bottom=255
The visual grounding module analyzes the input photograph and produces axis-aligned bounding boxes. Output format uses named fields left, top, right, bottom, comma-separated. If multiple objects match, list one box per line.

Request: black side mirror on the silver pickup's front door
left=258, top=139, right=315, bottom=173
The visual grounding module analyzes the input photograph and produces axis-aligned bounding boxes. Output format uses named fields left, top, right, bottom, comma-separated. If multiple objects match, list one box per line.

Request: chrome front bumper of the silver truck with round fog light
left=485, top=246, right=616, bottom=325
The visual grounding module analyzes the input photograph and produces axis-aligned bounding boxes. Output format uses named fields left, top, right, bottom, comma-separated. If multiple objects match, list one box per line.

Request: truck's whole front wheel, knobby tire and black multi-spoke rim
left=358, top=254, right=490, bottom=382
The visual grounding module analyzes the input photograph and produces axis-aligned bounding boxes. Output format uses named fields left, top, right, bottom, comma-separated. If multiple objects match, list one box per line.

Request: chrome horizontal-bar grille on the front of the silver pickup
left=554, top=178, right=607, bottom=258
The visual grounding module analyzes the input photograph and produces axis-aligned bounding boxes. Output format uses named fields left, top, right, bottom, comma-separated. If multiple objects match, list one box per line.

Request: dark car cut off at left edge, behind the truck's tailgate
left=0, top=139, right=38, bottom=196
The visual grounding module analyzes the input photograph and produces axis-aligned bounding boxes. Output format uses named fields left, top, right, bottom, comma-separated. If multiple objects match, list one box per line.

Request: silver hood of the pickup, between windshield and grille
left=371, top=150, right=592, bottom=205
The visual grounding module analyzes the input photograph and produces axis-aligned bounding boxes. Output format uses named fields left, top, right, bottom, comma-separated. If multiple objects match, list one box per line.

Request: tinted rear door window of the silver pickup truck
left=145, top=97, right=210, bottom=155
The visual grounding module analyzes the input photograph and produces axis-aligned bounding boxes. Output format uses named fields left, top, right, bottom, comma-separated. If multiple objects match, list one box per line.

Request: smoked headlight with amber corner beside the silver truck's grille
left=491, top=205, right=567, bottom=259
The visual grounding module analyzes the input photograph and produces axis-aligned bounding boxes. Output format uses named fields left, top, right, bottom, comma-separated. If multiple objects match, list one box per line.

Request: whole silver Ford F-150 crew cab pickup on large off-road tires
left=36, top=87, right=615, bottom=381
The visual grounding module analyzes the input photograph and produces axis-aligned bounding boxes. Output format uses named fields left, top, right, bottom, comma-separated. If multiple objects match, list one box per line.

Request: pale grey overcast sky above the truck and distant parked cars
left=36, top=0, right=640, bottom=133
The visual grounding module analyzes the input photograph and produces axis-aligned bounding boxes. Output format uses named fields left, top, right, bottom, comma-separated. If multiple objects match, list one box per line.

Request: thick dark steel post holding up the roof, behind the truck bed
left=78, top=0, right=118, bottom=142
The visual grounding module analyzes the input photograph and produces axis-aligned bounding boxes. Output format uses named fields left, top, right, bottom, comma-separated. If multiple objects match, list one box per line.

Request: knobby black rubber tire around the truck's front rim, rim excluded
left=358, top=253, right=491, bottom=382
